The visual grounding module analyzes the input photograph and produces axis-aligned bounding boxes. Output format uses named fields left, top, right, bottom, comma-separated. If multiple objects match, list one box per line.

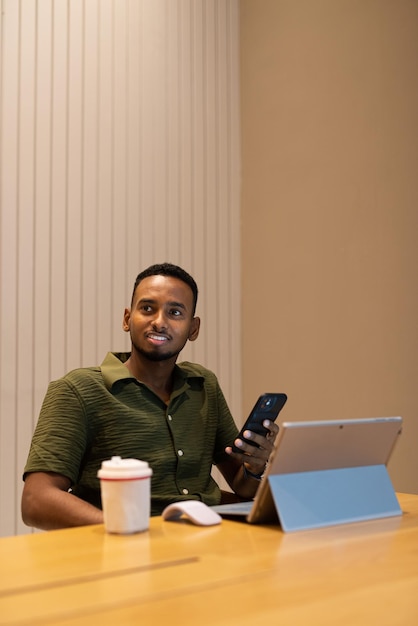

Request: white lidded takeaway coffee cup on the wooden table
left=97, top=456, right=152, bottom=534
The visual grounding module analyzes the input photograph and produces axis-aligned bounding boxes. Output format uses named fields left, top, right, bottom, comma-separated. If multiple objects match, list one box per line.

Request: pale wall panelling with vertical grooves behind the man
left=0, top=0, right=241, bottom=535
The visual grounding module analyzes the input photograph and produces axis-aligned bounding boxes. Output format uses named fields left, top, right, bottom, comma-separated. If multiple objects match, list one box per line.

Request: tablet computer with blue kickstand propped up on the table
left=214, top=416, right=402, bottom=531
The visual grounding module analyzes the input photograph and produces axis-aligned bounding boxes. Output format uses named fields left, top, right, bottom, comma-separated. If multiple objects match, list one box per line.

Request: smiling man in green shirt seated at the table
left=22, top=263, right=278, bottom=530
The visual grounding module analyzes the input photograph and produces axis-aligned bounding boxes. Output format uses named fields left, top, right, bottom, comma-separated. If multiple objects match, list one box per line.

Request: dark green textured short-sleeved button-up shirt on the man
left=24, top=353, right=238, bottom=515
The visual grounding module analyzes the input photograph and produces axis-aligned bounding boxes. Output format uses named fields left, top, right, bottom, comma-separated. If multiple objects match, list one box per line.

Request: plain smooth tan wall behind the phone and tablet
left=240, top=0, right=418, bottom=492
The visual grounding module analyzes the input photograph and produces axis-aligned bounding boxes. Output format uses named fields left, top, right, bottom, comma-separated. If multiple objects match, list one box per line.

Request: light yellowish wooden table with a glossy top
left=0, top=494, right=418, bottom=626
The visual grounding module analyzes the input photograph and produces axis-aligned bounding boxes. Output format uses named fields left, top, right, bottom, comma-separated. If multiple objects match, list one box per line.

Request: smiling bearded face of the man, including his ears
left=123, top=276, right=200, bottom=361
